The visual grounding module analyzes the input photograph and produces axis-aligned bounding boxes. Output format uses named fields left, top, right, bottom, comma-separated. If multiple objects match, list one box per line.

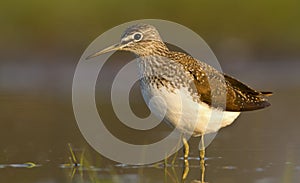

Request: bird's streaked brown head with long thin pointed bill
left=87, top=24, right=168, bottom=59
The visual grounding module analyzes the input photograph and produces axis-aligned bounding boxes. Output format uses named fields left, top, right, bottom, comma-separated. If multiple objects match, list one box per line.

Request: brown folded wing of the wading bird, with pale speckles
left=173, top=52, right=272, bottom=111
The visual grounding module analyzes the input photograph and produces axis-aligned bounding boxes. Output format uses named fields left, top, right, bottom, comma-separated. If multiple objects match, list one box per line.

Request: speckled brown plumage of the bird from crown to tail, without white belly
left=118, top=24, right=271, bottom=111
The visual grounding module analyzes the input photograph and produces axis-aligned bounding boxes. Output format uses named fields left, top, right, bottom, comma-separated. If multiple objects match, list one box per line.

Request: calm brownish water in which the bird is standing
left=0, top=59, right=300, bottom=183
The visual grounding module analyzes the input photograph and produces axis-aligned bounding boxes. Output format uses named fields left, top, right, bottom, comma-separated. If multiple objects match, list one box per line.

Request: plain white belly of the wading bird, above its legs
left=142, top=87, right=240, bottom=136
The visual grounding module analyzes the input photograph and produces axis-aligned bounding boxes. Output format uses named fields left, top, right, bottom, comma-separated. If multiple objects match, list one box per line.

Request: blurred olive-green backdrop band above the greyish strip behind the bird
left=0, top=0, right=300, bottom=61
